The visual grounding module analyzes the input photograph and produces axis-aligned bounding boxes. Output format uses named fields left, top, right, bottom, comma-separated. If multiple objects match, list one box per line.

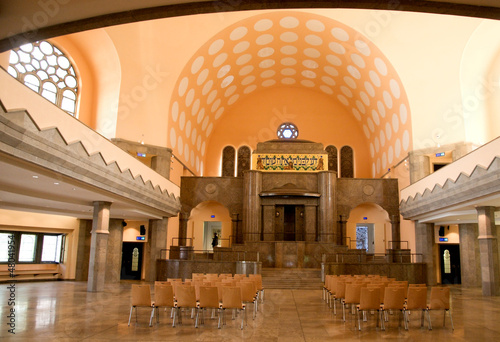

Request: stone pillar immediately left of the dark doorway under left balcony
left=105, top=219, right=123, bottom=283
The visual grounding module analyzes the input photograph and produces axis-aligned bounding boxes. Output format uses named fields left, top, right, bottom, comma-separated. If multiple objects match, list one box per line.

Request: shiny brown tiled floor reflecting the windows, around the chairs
left=0, top=281, right=500, bottom=342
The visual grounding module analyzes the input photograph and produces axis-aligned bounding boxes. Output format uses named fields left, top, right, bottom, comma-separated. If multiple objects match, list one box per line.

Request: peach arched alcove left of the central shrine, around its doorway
left=187, top=201, right=232, bottom=250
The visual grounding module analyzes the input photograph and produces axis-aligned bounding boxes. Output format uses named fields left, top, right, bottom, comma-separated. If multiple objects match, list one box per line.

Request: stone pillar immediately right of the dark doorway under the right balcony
left=458, top=223, right=481, bottom=287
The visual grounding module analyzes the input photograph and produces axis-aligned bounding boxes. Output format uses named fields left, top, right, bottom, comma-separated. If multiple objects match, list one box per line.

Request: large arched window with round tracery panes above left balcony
left=7, top=40, right=78, bottom=116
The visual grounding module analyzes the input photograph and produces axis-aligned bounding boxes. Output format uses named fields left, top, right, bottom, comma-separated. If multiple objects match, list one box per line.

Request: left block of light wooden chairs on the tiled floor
left=128, top=275, right=263, bottom=329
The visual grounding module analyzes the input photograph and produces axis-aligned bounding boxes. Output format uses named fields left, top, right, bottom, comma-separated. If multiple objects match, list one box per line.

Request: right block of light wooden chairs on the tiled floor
left=323, top=275, right=454, bottom=330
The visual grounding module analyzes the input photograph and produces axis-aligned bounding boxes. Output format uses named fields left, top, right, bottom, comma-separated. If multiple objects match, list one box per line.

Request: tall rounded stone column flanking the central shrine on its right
left=318, top=171, right=337, bottom=242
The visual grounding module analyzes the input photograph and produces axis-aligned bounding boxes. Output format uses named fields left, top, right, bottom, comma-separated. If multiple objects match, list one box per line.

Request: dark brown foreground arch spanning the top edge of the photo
left=0, top=0, right=500, bottom=52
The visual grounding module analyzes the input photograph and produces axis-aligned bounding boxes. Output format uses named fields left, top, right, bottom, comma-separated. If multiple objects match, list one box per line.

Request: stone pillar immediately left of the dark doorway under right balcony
left=415, top=222, right=437, bottom=286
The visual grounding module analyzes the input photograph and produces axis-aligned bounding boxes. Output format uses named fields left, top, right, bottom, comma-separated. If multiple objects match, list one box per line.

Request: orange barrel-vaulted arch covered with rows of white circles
left=168, top=11, right=412, bottom=176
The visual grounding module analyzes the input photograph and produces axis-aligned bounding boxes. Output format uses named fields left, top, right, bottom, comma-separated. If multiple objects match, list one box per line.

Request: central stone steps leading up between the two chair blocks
left=262, top=268, right=323, bottom=290
